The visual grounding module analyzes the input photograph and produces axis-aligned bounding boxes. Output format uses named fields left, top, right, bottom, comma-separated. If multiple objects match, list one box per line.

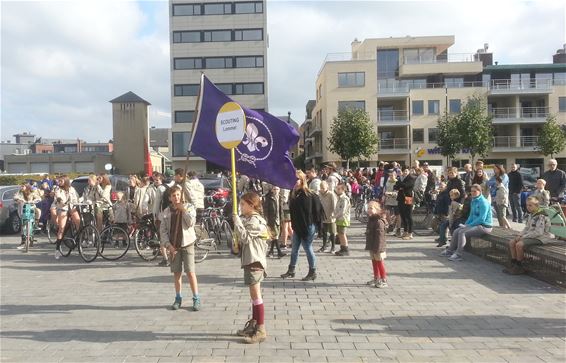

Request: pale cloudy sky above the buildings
left=0, top=0, right=566, bottom=142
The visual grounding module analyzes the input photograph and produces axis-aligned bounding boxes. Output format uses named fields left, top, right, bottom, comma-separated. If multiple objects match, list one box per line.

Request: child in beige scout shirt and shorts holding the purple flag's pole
left=160, top=185, right=200, bottom=311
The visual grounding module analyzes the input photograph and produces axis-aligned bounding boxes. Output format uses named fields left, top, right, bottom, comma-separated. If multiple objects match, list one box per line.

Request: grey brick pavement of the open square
left=0, top=225, right=566, bottom=363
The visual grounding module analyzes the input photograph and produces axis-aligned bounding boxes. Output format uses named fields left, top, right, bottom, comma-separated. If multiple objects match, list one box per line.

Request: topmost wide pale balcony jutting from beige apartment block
left=399, top=54, right=483, bottom=77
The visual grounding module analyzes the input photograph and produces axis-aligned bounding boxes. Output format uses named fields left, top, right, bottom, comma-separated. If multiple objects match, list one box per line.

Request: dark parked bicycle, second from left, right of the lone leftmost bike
left=59, top=203, right=100, bottom=263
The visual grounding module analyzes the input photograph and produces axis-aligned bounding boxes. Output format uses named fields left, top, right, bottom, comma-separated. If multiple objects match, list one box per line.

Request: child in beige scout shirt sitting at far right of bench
left=503, top=198, right=552, bottom=275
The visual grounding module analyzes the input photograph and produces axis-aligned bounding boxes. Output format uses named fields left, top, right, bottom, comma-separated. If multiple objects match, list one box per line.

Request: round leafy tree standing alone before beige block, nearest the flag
left=328, top=109, right=377, bottom=168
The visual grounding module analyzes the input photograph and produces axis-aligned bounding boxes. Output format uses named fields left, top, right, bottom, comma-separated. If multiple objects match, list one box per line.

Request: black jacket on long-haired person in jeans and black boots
left=289, top=190, right=325, bottom=239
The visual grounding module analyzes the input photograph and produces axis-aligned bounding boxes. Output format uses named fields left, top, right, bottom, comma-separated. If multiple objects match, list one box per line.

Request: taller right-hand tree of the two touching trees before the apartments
left=454, top=95, right=494, bottom=162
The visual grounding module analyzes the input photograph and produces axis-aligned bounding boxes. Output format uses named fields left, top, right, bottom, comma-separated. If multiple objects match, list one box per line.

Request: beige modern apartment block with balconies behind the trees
left=305, top=36, right=566, bottom=173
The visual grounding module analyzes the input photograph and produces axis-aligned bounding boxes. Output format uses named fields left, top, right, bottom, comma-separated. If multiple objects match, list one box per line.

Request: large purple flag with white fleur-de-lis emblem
left=189, top=74, right=299, bottom=189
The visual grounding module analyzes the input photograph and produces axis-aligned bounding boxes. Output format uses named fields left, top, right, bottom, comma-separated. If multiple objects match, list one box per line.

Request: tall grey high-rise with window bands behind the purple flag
left=169, top=0, right=268, bottom=172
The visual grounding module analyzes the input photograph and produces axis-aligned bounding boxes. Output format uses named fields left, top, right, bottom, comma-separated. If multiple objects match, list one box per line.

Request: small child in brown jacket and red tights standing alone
left=366, top=201, right=387, bottom=288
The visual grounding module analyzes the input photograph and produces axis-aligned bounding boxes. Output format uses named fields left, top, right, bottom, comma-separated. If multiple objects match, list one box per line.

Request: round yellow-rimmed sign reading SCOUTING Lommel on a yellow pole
left=216, top=102, right=246, bottom=149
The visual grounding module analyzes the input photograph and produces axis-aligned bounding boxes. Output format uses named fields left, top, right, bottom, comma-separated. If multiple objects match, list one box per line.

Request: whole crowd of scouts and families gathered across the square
left=10, top=160, right=566, bottom=343
